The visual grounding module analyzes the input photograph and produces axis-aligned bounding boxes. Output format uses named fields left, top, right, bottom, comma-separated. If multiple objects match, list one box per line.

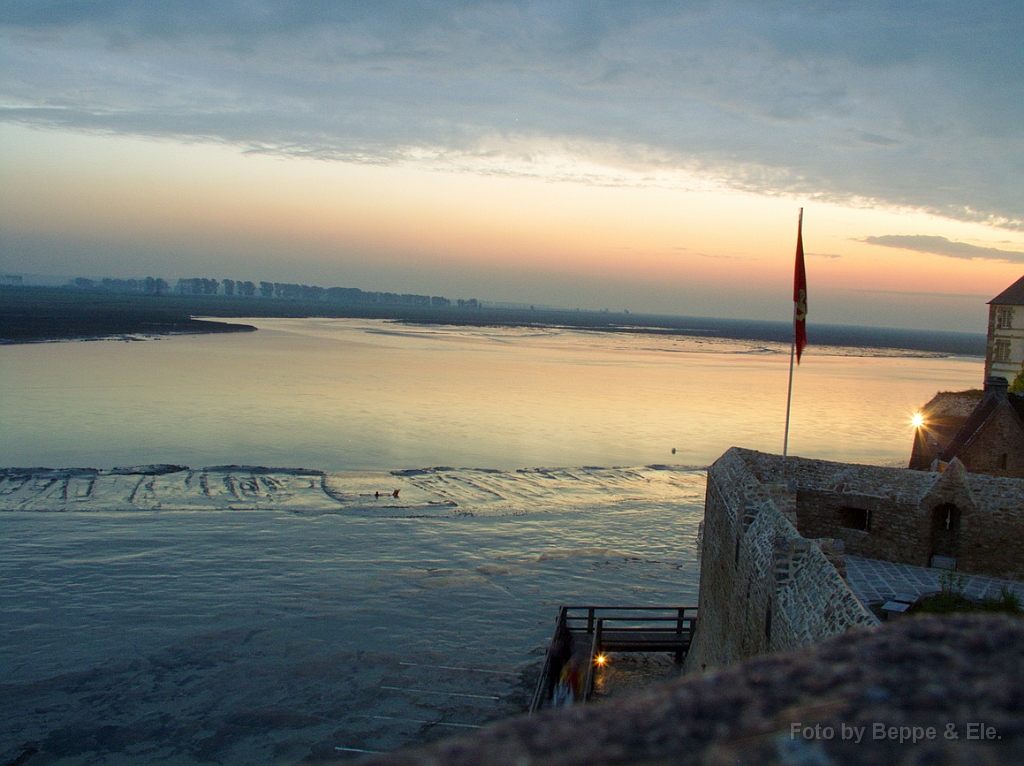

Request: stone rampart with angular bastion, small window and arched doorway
left=685, top=448, right=1024, bottom=671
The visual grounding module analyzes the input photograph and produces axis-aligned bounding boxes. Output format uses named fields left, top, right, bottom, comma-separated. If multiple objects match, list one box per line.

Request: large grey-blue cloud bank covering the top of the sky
left=0, top=0, right=1024, bottom=229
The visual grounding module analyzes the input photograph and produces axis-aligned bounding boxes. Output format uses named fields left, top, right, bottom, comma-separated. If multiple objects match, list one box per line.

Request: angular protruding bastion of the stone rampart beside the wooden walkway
left=686, top=448, right=878, bottom=671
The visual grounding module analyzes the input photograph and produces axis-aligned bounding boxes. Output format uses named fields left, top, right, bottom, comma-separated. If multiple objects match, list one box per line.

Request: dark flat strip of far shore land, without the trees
left=0, top=287, right=986, bottom=356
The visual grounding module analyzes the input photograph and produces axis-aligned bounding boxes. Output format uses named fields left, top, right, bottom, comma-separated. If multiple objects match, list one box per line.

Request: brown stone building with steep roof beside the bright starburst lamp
left=908, top=375, right=1024, bottom=478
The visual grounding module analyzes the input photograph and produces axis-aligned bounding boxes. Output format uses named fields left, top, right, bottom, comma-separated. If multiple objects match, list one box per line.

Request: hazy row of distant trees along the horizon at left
left=71, top=276, right=480, bottom=308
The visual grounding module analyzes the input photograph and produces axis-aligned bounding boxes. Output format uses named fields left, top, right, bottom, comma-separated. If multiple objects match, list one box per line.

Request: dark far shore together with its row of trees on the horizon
left=0, top=278, right=985, bottom=358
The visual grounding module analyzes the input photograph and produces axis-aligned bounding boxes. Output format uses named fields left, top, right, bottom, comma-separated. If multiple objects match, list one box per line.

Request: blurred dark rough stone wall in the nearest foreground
left=368, top=615, right=1024, bottom=766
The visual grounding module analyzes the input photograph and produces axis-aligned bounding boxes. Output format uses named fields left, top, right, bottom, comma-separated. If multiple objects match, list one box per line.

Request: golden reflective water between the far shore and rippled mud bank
left=0, top=320, right=983, bottom=470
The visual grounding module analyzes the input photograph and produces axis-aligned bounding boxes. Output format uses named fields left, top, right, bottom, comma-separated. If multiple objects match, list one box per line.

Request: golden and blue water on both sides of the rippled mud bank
left=0, top=320, right=982, bottom=766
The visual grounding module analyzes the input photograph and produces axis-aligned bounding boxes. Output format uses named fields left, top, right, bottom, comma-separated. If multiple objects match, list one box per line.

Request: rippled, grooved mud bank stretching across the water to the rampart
left=0, top=466, right=703, bottom=516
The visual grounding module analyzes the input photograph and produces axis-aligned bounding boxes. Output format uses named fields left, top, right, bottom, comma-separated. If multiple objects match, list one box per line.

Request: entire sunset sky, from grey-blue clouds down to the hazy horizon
left=0, top=0, right=1024, bottom=333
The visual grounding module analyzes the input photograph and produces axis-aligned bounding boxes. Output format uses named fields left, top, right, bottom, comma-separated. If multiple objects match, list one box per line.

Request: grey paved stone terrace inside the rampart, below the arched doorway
left=846, top=556, right=1024, bottom=604
